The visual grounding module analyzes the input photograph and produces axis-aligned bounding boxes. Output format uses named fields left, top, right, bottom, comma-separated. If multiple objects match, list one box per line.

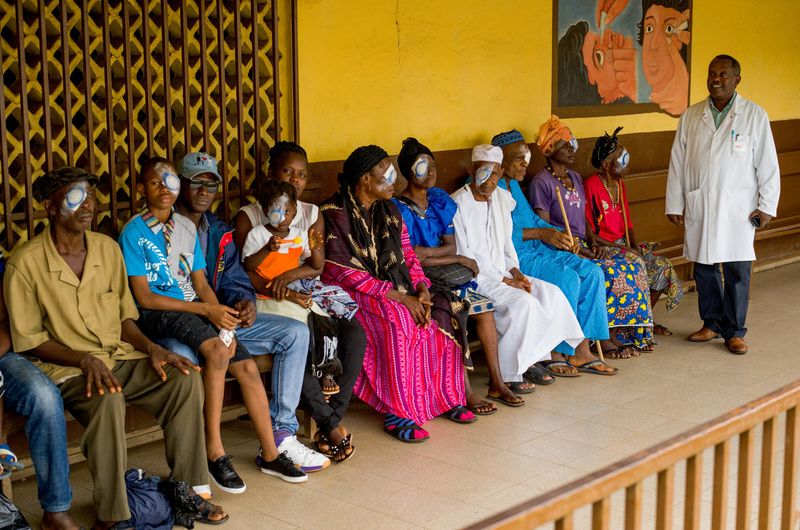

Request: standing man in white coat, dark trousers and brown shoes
left=666, top=55, right=780, bottom=354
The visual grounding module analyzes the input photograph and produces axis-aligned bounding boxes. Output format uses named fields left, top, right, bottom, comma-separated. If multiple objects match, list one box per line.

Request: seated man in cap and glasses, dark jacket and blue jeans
left=170, top=152, right=330, bottom=473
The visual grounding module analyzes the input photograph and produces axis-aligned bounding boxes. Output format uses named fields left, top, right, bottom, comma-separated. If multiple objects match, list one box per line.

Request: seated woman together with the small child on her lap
left=234, top=142, right=366, bottom=462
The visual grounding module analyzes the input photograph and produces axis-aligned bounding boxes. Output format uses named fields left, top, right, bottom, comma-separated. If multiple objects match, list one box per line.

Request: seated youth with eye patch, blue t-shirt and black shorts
left=119, top=158, right=307, bottom=493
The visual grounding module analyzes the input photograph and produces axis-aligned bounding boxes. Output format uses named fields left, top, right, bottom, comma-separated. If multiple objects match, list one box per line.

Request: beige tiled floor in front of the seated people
left=14, top=264, right=800, bottom=529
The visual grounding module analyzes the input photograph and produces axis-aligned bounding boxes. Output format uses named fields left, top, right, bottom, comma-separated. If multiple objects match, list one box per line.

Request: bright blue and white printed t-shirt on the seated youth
left=119, top=214, right=206, bottom=302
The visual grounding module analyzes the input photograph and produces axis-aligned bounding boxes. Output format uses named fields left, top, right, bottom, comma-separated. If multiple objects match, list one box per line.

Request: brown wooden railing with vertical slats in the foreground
left=469, top=380, right=800, bottom=530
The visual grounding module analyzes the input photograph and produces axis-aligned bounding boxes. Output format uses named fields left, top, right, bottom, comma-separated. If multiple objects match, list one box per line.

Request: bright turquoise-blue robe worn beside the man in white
left=500, top=178, right=608, bottom=355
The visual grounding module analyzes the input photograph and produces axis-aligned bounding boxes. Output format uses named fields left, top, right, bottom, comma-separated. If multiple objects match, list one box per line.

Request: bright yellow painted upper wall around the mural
left=290, top=0, right=800, bottom=161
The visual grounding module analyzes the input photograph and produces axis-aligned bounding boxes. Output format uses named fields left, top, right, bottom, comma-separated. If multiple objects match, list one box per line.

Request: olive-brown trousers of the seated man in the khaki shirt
left=59, top=359, right=208, bottom=521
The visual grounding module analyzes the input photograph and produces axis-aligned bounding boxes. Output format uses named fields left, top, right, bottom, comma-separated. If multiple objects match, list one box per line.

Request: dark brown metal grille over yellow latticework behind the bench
left=0, top=0, right=279, bottom=249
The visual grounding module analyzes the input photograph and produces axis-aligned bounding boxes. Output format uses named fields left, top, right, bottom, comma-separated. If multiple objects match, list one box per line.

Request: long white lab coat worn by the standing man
left=666, top=94, right=780, bottom=265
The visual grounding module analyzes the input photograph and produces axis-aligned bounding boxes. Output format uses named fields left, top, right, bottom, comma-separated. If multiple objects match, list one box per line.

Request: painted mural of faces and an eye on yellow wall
left=553, top=0, right=691, bottom=117
